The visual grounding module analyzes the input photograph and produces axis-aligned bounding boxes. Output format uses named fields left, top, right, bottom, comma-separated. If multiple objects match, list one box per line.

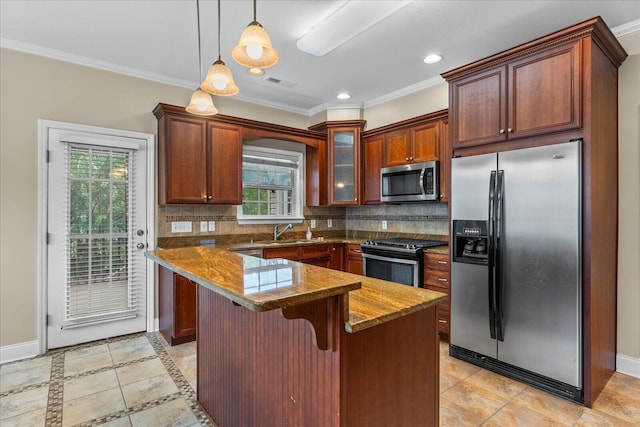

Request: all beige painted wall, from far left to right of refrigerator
left=0, top=29, right=640, bottom=364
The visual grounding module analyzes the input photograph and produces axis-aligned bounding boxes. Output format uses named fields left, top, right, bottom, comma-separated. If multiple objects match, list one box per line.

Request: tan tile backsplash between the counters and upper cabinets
left=157, top=203, right=449, bottom=240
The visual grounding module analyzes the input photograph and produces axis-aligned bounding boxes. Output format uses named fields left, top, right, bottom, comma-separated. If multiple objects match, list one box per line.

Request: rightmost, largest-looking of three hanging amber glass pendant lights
left=231, top=0, right=278, bottom=69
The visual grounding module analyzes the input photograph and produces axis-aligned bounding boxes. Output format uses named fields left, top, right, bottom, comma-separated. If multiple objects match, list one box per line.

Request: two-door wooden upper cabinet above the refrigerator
left=449, top=40, right=582, bottom=149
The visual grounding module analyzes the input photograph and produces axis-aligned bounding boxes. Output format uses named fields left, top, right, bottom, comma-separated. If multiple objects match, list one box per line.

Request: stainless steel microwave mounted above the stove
left=380, top=160, right=440, bottom=202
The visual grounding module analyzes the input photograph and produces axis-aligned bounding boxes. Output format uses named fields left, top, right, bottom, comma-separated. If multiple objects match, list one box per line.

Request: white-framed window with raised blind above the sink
left=238, top=146, right=304, bottom=224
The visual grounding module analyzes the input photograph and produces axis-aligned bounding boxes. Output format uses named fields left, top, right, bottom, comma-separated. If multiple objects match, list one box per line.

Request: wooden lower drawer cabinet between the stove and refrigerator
left=424, top=252, right=451, bottom=339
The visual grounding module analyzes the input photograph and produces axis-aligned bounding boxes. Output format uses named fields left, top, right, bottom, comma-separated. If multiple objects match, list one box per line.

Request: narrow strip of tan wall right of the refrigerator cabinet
left=617, top=32, right=640, bottom=359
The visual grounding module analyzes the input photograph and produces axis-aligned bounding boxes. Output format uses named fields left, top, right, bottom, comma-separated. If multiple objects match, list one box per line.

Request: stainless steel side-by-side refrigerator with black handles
left=450, top=140, right=583, bottom=402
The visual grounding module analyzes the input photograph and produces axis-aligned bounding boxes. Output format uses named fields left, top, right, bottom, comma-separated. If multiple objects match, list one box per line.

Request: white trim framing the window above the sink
left=236, top=145, right=305, bottom=224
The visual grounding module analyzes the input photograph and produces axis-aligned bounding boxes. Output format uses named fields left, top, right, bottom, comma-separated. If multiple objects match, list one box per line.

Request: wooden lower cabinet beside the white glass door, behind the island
left=158, top=267, right=197, bottom=345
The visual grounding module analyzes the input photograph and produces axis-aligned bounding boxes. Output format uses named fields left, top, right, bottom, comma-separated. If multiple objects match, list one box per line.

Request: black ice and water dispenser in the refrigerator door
left=453, top=220, right=489, bottom=265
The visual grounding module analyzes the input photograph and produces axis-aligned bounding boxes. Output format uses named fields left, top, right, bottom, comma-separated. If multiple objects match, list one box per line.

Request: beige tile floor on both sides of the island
left=0, top=334, right=640, bottom=427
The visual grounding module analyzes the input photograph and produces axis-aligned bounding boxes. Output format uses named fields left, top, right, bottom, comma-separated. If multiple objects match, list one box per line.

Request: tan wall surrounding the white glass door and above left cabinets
left=0, top=49, right=309, bottom=346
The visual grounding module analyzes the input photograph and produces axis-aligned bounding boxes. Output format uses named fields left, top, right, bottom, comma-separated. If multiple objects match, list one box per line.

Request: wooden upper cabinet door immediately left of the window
left=207, top=122, right=242, bottom=205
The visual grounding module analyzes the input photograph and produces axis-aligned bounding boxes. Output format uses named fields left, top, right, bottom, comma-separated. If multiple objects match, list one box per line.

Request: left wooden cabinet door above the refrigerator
left=449, top=66, right=507, bottom=148
